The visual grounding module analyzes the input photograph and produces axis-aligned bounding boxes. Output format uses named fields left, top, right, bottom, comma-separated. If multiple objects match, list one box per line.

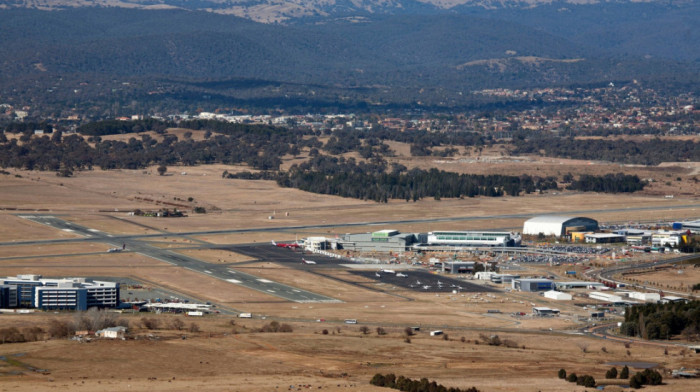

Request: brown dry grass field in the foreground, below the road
left=0, top=315, right=700, bottom=392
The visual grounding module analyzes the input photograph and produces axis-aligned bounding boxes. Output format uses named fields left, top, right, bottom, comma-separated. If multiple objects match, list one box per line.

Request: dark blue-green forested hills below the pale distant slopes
left=0, top=8, right=700, bottom=113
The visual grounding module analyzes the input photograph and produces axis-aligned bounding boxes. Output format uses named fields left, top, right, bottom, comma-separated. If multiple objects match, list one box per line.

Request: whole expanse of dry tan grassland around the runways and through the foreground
left=0, top=156, right=700, bottom=392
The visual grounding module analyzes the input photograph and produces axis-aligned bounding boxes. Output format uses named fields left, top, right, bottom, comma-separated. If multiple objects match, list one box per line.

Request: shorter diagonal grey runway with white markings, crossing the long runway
left=21, top=215, right=340, bottom=302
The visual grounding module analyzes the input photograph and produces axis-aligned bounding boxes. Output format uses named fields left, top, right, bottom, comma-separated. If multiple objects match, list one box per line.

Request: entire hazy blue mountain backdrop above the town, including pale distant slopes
left=0, top=0, right=700, bottom=112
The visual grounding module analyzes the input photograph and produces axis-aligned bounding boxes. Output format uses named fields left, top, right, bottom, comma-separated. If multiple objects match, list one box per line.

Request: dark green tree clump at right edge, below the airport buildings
left=620, top=301, right=700, bottom=341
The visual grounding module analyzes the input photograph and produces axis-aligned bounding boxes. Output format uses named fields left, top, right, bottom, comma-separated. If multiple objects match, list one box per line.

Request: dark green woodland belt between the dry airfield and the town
left=0, top=120, right=646, bottom=202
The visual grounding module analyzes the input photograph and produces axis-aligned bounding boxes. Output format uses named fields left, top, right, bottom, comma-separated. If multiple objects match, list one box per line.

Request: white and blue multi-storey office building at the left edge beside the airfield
left=0, top=275, right=119, bottom=310
